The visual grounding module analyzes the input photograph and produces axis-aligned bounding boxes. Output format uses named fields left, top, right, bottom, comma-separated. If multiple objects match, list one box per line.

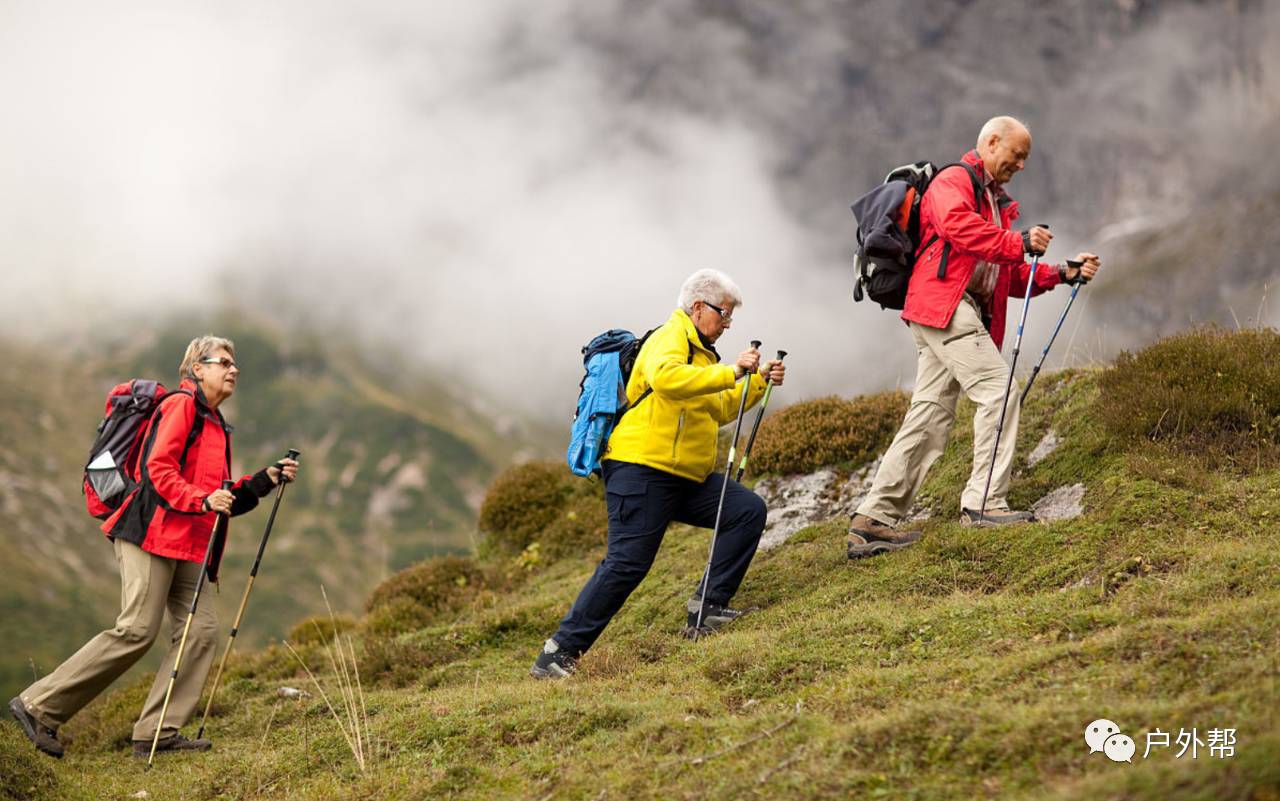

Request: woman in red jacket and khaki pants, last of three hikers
left=9, top=337, right=298, bottom=756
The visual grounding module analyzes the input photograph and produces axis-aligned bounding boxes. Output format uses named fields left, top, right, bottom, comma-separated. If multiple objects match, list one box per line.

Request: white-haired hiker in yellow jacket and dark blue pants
left=530, top=270, right=785, bottom=678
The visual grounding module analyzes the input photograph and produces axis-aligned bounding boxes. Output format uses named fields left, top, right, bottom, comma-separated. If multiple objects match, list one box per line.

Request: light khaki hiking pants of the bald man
left=858, top=294, right=1020, bottom=526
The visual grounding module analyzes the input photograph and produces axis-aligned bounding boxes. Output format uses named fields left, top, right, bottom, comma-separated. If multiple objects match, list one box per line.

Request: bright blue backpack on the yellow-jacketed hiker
left=564, top=329, right=694, bottom=476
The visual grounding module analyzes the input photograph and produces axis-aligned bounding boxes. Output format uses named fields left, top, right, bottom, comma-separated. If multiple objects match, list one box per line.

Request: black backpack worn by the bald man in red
left=851, top=161, right=982, bottom=310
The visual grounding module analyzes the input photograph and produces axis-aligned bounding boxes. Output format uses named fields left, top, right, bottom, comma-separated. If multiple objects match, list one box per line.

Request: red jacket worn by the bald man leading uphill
left=902, top=150, right=1060, bottom=348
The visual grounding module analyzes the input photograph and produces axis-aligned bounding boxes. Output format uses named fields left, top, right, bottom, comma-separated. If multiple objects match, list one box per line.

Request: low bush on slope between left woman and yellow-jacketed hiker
left=365, top=557, right=497, bottom=636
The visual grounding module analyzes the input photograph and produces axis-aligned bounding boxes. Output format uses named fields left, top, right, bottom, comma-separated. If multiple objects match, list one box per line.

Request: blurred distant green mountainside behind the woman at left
left=0, top=319, right=555, bottom=699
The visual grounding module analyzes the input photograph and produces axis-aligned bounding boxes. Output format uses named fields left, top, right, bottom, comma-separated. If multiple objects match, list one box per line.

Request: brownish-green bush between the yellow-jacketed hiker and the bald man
left=751, top=392, right=910, bottom=475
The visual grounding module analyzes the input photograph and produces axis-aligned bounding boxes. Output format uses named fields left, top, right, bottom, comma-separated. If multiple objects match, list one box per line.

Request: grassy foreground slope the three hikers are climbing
left=0, top=326, right=1280, bottom=801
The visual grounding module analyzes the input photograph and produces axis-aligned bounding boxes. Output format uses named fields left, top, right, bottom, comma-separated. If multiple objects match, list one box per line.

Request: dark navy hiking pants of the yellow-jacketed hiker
left=554, top=461, right=765, bottom=654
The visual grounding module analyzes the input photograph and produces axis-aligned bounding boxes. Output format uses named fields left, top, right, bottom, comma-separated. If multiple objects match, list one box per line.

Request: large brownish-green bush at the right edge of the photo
left=1092, top=321, right=1280, bottom=467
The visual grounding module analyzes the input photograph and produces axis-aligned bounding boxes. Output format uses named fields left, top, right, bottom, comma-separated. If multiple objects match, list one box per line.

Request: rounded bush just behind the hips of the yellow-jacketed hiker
left=480, top=462, right=573, bottom=554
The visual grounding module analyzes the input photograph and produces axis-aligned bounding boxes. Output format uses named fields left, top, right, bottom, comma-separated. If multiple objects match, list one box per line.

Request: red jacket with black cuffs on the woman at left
left=102, top=379, right=273, bottom=580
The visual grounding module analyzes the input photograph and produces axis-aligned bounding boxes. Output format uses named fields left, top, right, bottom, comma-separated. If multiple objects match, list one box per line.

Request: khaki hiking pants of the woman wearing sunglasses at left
left=20, top=540, right=218, bottom=740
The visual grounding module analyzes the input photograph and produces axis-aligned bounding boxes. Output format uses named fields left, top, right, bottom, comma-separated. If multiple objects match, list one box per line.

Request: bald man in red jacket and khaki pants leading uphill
left=849, top=116, right=1100, bottom=559
